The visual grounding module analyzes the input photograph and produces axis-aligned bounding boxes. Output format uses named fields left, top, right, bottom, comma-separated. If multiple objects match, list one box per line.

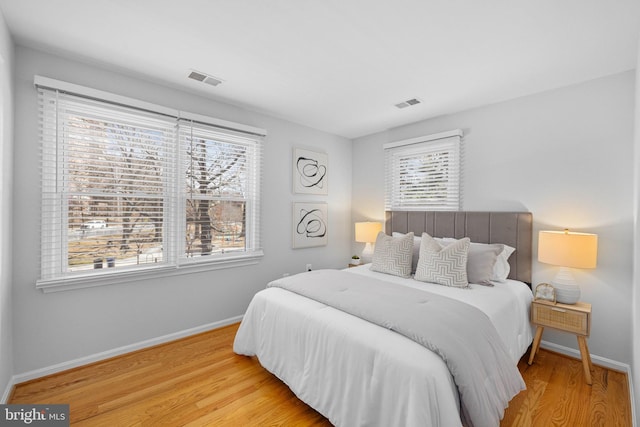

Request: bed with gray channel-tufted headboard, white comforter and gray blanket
left=234, top=212, right=532, bottom=427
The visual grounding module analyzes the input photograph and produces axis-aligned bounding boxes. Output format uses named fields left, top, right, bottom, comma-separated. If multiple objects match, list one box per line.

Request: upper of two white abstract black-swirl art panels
left=292, top=148, right=329, bottom=196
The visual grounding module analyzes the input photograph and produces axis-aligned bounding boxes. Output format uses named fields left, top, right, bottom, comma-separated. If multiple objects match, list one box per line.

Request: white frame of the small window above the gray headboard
left=383, top=129, right=464, bottom=211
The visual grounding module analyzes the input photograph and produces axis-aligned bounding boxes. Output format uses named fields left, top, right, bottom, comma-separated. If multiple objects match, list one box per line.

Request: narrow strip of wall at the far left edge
left=0, top=6, right=13, bottom=402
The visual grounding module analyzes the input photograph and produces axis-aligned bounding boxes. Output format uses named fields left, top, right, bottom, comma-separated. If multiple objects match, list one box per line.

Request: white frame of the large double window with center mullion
left=34, top=76, right=267, bottom=293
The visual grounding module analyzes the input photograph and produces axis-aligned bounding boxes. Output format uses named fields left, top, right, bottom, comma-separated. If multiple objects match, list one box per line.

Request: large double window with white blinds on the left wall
left=36, top=78, right=264, bottom=290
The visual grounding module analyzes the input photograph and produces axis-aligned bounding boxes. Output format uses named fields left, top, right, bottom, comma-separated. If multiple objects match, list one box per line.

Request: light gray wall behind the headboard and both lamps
left=352, top=71, right=635, bottom=364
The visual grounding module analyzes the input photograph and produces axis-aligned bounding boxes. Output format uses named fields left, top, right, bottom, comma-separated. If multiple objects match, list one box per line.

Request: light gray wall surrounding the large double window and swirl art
left=13, top=47, right=352, bottom=374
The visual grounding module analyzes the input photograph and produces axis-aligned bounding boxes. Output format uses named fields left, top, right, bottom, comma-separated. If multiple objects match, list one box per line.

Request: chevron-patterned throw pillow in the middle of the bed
left=414, top=233, right=471, bottom=288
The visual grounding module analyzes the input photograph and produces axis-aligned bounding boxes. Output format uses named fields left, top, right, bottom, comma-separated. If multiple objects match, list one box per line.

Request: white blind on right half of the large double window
left=179, top=120, right=262, bottom=260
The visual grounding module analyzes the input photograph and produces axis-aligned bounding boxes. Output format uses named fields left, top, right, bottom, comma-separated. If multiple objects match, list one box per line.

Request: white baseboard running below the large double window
left=10, top=315, right=243, bottom=388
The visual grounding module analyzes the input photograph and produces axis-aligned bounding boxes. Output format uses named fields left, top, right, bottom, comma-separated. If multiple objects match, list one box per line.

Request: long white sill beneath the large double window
left=36, top=251, right=264, bottom=293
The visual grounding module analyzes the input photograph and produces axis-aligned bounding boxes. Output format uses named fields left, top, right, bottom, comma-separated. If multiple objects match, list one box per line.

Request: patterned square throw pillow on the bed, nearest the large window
left=371, top=231, right=413, bottom=277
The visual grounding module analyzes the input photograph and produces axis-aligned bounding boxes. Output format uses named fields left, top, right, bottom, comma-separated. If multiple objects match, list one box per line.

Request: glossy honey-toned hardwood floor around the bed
left=8, top=324, right=631, bottom=427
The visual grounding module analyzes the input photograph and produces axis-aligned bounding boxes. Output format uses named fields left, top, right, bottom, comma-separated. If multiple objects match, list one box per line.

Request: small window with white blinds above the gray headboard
left=384, top=130, right=462, bottom=210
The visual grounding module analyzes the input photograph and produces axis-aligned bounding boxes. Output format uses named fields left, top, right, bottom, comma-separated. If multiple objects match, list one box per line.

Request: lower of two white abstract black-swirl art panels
left=292, top=202, right=328, bottom=249
